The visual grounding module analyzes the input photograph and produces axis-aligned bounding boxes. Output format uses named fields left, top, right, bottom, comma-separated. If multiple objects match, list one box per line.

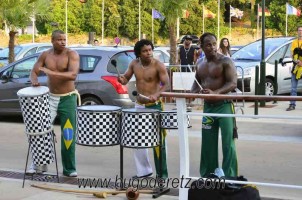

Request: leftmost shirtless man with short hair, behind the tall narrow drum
left=28, top=30, right=80, bottom=177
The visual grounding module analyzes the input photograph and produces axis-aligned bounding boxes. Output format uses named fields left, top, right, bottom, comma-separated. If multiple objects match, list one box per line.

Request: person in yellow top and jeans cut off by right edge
left=286, top=25, right=302, bottom=111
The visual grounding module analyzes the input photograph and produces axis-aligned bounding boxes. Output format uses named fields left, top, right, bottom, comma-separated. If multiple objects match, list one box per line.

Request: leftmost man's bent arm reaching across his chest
left=39, top=50, right=80, bottom=81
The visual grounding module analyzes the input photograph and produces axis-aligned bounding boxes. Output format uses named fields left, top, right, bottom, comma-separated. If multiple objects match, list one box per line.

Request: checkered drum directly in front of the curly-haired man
left=121, top=108, right=159, bottom=148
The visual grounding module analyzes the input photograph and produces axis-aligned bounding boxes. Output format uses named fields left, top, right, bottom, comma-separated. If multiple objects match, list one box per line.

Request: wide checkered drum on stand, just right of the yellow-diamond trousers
left=76, top=105, right=121, bottom=146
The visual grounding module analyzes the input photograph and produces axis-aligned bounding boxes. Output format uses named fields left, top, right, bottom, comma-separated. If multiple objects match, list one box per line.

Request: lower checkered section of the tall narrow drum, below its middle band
left=27, top=131, right=55, bottom=166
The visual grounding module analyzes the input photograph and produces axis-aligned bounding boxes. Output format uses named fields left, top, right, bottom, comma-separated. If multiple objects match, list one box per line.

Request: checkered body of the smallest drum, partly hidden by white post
left=160, top=110, right=191, bottom=129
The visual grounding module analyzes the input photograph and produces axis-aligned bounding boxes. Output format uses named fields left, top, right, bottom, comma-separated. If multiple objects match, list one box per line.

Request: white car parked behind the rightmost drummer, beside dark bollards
left=232, top=37, right=302, bottom=95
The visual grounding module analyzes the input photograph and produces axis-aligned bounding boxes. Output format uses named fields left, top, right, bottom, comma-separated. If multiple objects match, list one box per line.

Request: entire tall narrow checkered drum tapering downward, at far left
left=17, top=86, right=55, bottom=165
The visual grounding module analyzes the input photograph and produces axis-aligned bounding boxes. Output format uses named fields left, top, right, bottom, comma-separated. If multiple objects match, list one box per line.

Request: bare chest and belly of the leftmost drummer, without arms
left=45, top=49, right=75, bottom=94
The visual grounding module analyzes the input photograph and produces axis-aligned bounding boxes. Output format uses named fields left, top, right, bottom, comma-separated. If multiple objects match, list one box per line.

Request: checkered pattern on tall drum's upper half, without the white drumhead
left=19, top=93, right=51, bottom=133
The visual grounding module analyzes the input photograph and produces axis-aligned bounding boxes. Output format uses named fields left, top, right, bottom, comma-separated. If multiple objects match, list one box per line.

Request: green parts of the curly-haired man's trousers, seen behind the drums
left=145, top=101, right=168, bottom=178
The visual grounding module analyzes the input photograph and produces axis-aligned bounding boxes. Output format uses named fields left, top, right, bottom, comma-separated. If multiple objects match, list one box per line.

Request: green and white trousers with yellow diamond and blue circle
left=49, top=94, right=77, bottom=176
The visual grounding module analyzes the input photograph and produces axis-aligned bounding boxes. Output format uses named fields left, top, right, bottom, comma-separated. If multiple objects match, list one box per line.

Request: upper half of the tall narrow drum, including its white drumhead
left=17, top=86, right=51, bottom=134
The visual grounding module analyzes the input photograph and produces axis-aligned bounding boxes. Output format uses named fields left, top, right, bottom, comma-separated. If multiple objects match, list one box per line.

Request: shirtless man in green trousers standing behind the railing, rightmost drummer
left=191, top=33, right=238, bottom=177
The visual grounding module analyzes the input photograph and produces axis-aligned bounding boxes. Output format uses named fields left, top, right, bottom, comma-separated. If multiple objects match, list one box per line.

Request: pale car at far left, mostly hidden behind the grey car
left=0, top=43, right=52, bottom=67
